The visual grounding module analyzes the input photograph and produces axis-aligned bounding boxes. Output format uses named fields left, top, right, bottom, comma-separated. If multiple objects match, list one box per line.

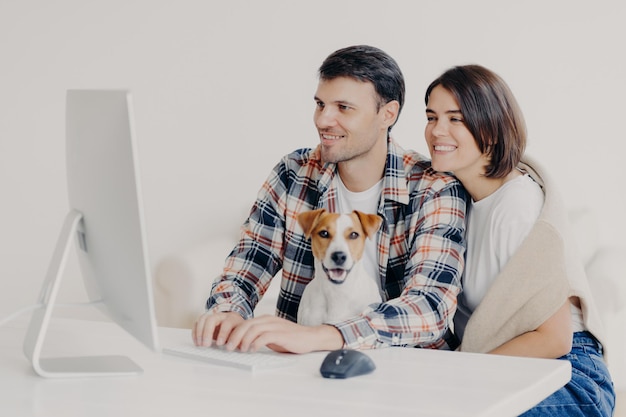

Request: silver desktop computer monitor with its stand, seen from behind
left=24, top=90, right=159, bottom=377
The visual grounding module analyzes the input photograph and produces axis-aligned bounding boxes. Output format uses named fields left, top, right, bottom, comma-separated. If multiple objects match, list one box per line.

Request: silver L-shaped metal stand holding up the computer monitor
left=24, top=210, right=143, bottom=378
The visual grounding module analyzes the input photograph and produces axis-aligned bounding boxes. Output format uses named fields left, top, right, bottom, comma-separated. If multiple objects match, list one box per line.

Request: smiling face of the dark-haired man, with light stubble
left=313, top=77, right=390, bottom=163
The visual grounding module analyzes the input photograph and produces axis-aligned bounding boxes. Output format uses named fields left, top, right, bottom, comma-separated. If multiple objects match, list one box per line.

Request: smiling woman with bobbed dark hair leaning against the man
left=425, top=65, right=615, bottom=416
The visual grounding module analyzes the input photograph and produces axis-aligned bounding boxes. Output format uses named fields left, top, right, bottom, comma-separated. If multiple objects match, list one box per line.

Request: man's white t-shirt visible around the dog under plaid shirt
left=335, top=175, right=383, bottom=297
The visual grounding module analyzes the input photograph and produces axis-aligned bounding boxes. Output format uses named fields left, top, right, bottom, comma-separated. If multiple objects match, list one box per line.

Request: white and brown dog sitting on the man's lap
left=297, top=209, right=382, bottom=326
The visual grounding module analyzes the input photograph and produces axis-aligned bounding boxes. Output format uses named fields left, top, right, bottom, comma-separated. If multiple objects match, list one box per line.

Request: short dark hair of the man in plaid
left=318, top=45, right=405, bottom=130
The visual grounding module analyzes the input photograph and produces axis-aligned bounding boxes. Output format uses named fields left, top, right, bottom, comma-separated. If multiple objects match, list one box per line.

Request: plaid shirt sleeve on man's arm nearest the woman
left=333, top=169, right=466, bottom=348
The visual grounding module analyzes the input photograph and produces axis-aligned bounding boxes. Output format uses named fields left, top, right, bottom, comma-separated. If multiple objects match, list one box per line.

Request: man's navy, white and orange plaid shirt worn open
left=207, top=139, right=467, bottom=348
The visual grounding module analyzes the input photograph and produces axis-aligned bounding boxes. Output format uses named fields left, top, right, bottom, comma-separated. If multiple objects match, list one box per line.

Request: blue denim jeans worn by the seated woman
left=522, top=332, right=615, bottom=417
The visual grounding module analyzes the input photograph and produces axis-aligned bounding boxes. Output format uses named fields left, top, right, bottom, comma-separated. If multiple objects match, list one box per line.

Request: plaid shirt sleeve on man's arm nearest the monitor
left=206, top=149, right=321, bottom=321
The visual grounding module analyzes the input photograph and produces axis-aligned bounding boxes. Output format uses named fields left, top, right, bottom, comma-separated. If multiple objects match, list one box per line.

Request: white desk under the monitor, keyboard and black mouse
left=0, top=318, right=570, bottom=417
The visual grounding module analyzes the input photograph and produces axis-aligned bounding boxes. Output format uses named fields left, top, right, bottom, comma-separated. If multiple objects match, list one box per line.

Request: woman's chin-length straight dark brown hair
left=425, top=65, right=526, bottom=178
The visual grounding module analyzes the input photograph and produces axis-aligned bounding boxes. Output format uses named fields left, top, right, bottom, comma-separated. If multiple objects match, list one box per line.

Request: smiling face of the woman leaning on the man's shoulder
left=424, top=85, right=489, bottom=181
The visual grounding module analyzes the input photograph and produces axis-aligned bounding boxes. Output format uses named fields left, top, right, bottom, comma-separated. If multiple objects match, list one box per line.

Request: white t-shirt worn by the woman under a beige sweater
left=454, top=175, right=544, bottom=339
